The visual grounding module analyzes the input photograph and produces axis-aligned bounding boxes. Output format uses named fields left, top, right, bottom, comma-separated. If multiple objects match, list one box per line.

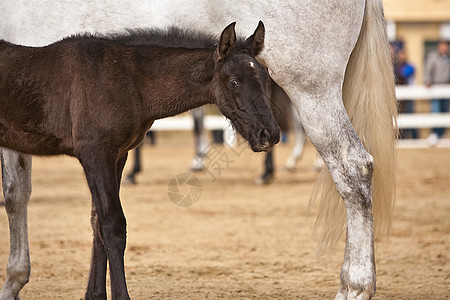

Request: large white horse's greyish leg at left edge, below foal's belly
left=0, top=148, right=31, bottom=300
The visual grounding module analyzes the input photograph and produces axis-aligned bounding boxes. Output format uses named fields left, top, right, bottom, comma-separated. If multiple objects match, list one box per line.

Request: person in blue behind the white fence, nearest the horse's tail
left=394, top=48, right=417, bottom=139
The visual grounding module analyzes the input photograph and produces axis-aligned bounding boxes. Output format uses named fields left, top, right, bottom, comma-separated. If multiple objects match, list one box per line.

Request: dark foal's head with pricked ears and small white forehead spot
left=213, top=22, right=280, bottom=152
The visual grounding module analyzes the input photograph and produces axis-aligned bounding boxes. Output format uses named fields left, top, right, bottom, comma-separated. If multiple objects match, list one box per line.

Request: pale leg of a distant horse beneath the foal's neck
left=190, top=107, right=208, bottom=172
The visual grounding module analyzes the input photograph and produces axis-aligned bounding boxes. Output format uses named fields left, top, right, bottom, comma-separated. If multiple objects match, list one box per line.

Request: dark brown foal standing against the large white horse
left=0, top=22, right=280, bottom=299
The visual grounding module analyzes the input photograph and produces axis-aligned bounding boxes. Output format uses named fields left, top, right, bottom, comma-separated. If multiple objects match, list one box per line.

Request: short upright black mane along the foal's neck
left=64, top=26, right=247, bottom=50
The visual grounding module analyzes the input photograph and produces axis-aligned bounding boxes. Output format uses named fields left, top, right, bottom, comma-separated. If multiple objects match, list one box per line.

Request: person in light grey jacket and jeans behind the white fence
left=425, top=41, right=450, bottom=146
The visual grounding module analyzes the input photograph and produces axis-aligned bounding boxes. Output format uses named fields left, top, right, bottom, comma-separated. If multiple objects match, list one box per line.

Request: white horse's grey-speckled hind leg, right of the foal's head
left=293, top=84, right=376, bottom=300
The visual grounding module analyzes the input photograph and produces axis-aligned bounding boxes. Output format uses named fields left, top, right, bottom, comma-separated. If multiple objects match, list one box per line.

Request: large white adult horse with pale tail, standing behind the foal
left=0, top=0, right=397, bottom=299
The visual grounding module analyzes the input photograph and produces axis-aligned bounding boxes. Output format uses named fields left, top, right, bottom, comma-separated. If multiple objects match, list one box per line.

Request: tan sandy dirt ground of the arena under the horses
left=0, top=134, right=450, bottom=299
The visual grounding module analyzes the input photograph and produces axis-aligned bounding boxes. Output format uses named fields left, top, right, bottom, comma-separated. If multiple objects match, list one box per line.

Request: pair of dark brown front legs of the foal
left=79, top=147, right=130, bottom=299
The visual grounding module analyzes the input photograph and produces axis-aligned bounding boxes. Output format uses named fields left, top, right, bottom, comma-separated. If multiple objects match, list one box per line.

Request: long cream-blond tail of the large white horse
left=312, top=0, right=397, bottom=248
